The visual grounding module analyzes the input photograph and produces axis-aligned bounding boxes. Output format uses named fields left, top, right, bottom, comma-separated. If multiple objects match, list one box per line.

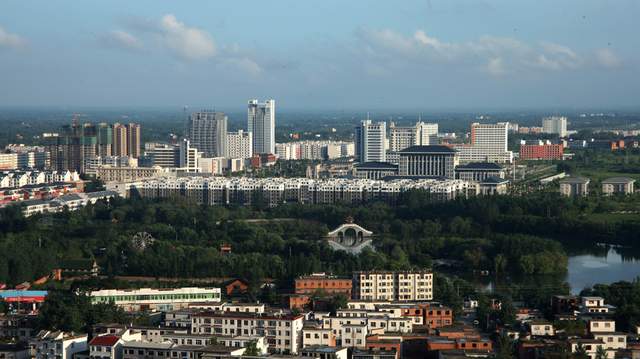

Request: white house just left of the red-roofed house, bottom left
left=29, top=330, right=87, bottom=359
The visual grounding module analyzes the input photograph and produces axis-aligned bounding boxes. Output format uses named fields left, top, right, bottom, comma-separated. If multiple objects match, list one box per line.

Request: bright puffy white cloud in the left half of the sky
left=160, top=14, right=216, bottom=60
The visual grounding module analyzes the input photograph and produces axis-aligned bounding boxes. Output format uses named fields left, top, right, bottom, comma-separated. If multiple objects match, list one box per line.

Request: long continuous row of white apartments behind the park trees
left=120, top=177, right=478, bottom=207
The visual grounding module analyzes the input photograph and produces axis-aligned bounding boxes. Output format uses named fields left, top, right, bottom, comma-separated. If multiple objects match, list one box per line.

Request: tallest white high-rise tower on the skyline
left=247, top=100, right=276, bottom=154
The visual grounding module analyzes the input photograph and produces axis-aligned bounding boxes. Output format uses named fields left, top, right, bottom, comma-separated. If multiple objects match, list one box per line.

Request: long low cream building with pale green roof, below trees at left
left=89, top=287, right=221, bottom=311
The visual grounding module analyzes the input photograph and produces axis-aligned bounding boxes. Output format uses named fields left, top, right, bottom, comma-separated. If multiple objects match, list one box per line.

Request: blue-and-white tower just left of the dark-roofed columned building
left=355, top=120, right=387, bottom=163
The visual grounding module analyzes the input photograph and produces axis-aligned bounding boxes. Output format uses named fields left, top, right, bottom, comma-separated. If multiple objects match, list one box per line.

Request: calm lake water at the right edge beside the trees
left=567, top=248, right=640, bottom=294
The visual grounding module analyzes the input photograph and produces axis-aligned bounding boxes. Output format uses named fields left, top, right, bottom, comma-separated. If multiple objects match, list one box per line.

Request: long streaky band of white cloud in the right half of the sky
left=358, top=29, right=584, bottom=76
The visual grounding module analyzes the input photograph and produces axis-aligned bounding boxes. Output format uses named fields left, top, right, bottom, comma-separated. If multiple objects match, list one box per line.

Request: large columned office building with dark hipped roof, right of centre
left=398, top=145, right=458, bottom=179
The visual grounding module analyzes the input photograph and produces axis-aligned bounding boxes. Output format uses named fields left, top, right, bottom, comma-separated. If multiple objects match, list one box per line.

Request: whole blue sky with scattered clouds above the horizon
left=0, top=0, right=640, bottom=109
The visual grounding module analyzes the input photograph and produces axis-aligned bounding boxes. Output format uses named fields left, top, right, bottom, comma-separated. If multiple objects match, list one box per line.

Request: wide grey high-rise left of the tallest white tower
left=187, top=111, right=227, bottom=157
